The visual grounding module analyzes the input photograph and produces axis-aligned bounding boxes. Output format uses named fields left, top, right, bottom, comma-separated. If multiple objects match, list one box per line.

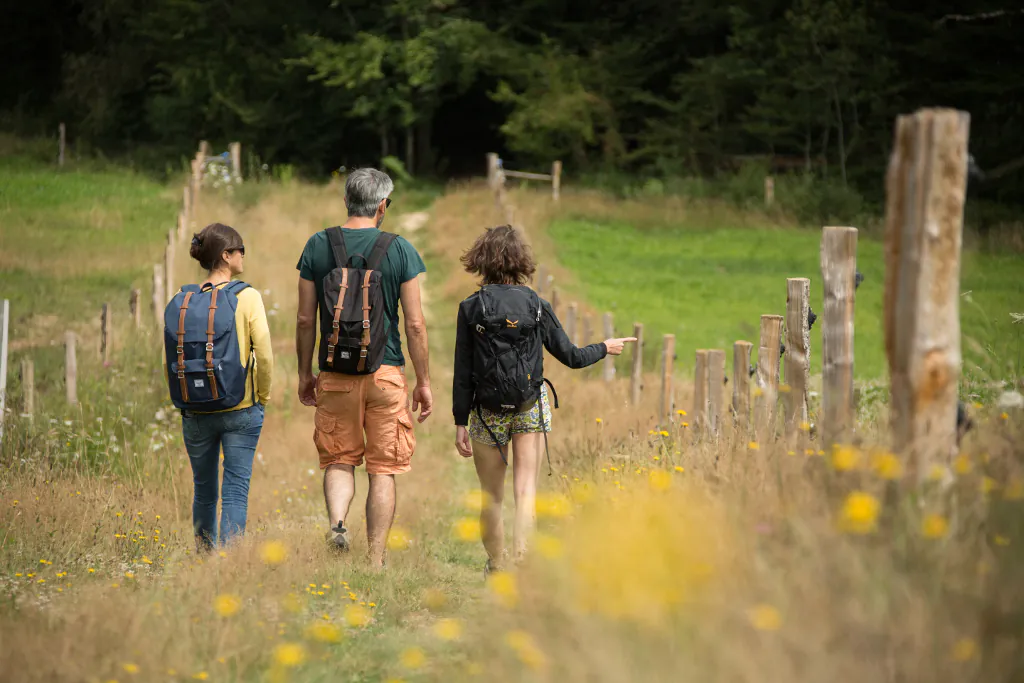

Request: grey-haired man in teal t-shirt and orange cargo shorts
left=295, top=168, right=433, bottom=567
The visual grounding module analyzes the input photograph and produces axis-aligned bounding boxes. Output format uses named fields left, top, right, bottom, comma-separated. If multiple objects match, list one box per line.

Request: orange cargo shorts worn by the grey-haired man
left=313, top=366, right=416, bottom=474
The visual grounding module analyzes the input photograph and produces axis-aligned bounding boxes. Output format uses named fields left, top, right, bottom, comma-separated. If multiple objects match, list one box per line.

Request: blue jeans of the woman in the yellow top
left=181, top=403, right=263, bottom=549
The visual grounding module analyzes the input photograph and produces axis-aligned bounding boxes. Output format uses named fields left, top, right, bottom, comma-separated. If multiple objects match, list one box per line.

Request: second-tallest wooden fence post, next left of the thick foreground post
left=821, top=226, right=860, bottom=447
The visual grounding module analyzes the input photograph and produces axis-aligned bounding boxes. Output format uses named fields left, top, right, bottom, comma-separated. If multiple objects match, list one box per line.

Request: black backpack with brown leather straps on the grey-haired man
left=319, top=227, right=397, bottom=375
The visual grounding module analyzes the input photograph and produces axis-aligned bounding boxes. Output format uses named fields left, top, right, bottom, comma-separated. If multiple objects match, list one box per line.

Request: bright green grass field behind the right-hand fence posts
left=550, top=217, right=1024, bottom=389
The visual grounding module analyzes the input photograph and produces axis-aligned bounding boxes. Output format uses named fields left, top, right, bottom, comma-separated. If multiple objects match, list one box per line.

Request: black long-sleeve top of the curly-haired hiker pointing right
left=452, top=294, right=608, bottom=427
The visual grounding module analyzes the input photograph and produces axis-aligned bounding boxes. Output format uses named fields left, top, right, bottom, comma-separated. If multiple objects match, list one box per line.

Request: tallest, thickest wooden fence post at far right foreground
left=880, top=109, right=971, bottom=480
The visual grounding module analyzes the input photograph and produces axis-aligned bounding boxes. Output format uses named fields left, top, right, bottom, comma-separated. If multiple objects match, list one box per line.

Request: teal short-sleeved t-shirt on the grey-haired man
left=295, top=227, right=427, bottom=366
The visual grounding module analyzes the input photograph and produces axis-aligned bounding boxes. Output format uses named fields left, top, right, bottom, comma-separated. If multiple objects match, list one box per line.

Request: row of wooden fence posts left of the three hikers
left=0, top=139, right=242, bottom=439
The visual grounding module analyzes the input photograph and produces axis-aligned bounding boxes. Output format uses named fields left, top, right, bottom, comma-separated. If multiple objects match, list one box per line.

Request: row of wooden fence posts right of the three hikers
left=524, top=109, right=970, bottom=482
